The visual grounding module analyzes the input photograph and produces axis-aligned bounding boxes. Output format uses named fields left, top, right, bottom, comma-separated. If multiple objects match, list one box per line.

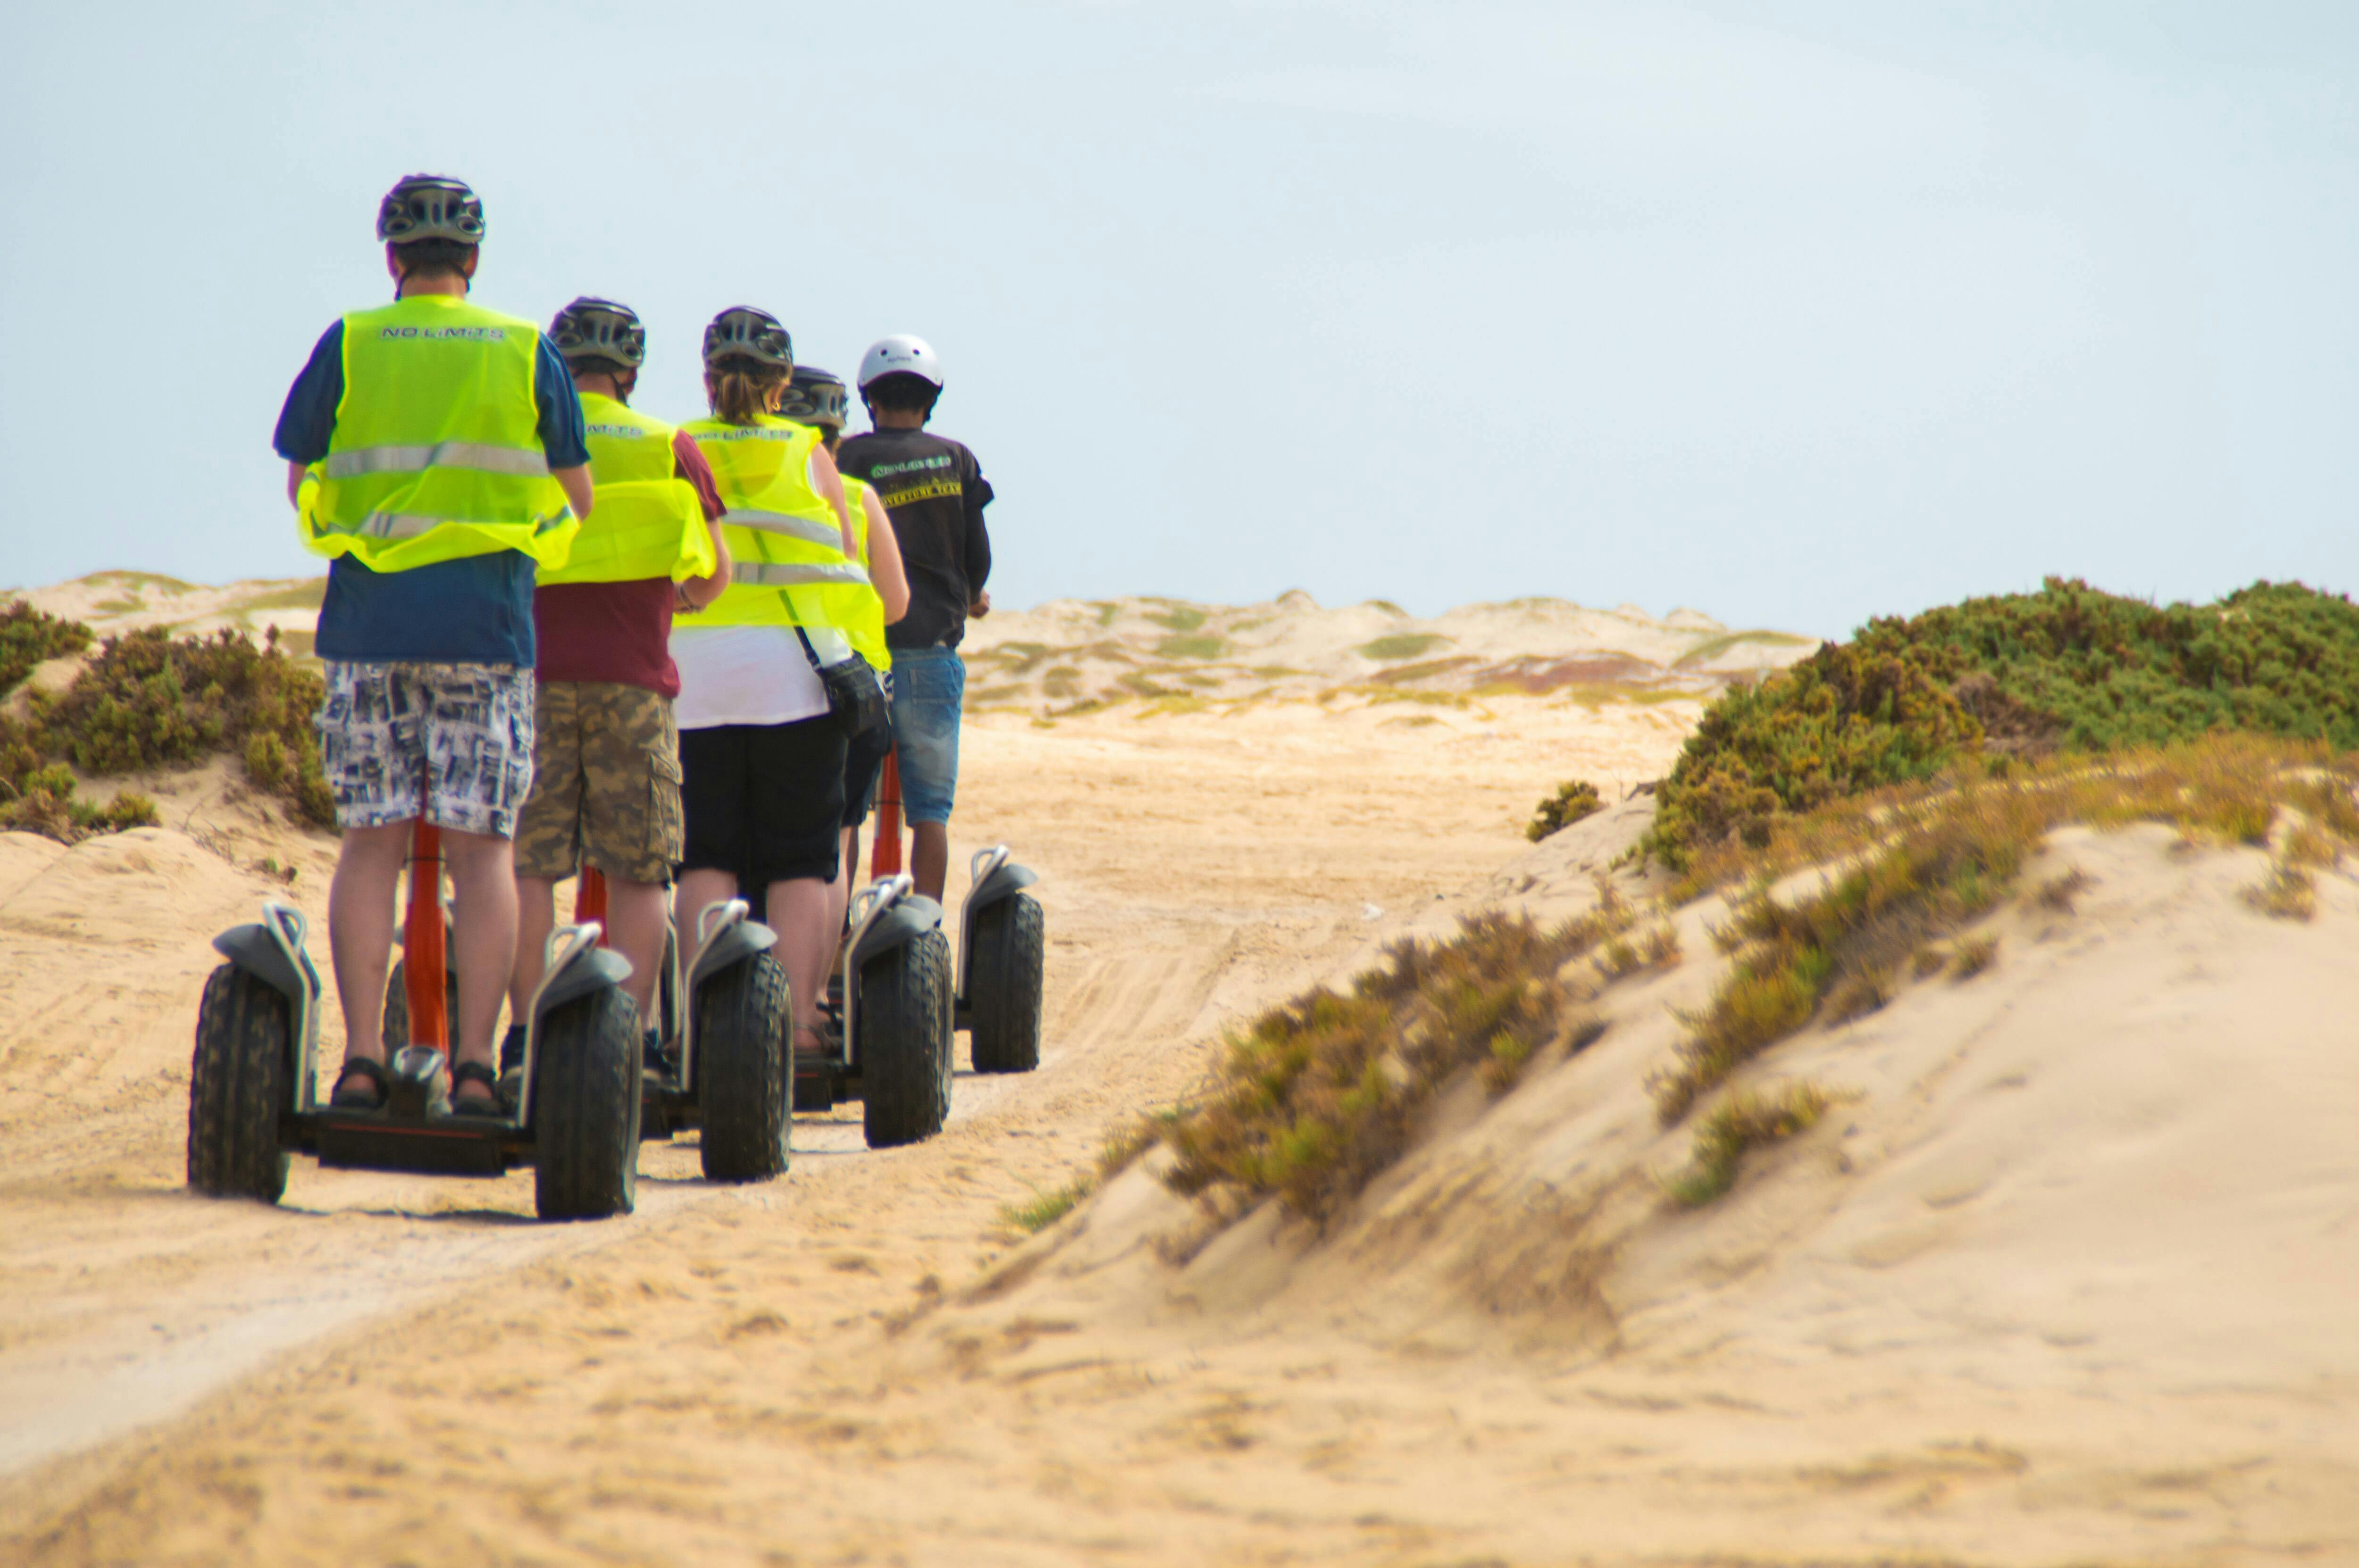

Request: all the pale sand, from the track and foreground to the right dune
left=0, top=580, right=2359, bottom=1566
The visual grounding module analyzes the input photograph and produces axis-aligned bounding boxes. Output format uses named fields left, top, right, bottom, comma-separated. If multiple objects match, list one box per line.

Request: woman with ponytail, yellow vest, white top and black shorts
left=672, top=304, right=868, bottom=1066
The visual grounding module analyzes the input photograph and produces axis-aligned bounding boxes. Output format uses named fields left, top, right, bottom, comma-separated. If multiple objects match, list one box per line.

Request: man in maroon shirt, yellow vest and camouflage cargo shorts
left=500, top=297, right=729, bottom=1077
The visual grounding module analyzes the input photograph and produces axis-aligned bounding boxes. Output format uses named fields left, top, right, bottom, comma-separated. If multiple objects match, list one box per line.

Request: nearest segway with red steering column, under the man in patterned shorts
left=189, top=823, right=639, bottom=1219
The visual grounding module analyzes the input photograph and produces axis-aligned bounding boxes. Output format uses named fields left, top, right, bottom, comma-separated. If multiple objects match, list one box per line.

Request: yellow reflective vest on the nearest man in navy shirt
left=297, top=295, right=580, bottom=571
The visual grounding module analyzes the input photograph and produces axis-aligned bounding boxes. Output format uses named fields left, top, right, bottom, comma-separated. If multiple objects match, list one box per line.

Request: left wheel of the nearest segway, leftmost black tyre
left=189, top=964, right=295, bottom=1202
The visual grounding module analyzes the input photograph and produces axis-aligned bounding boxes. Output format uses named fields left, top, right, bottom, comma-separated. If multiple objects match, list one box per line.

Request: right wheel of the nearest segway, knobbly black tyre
left=528, top=985, right=639, bottom=1219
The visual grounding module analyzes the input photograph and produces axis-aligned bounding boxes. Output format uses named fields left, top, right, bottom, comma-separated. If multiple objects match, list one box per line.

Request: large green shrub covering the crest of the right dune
left=1642, top=578, right=2359, bottom=870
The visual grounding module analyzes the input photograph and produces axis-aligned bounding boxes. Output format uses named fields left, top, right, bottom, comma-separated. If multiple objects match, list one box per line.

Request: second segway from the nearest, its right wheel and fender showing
left=637, top=872, right=793, bottom=1181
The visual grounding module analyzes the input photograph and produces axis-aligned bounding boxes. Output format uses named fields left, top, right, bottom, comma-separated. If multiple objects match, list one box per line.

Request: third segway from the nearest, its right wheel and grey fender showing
left=795, top=872, right=951, bottom=1148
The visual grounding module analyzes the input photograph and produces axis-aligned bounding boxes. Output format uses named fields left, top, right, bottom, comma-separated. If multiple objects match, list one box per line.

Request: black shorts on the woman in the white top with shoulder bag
left=679, top=715, right=845, bottom=886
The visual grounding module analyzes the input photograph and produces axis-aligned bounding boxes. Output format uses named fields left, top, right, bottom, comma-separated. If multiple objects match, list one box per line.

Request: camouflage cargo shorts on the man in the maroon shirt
left=517, top=682, right=679, bottom=882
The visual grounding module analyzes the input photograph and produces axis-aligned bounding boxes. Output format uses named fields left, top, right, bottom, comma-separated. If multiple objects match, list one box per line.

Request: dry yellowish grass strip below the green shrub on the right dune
left=1654, top=736, right=2359, bottom=1125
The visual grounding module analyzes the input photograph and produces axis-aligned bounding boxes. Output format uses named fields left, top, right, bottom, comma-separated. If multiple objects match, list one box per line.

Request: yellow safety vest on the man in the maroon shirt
left=540, top=392, right=712, bottom=585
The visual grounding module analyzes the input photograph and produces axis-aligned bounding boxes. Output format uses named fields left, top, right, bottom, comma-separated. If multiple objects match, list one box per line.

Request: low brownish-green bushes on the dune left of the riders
left=0, top=601, right=335, bottom=842
